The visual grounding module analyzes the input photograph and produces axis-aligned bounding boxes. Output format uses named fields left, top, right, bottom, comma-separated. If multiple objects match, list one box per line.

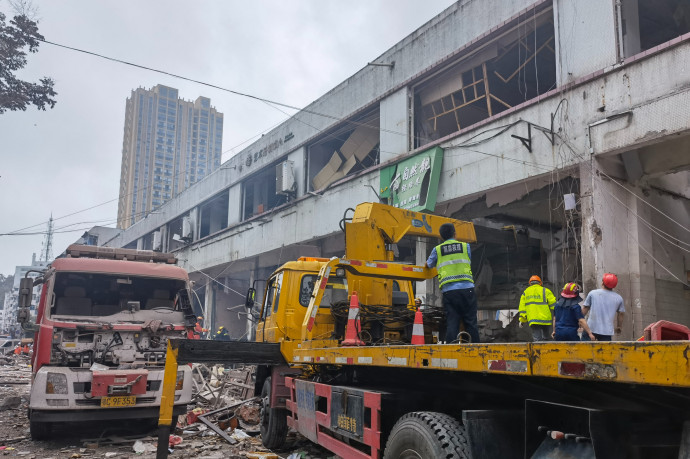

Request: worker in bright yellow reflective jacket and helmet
left=519, top=276, right=556, bottom=341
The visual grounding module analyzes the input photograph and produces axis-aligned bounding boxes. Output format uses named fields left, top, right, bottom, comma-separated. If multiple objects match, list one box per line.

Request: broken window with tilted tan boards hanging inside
left=307, top=109, right=379, bottom=190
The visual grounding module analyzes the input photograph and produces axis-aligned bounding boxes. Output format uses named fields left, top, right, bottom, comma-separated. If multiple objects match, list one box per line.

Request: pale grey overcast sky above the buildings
left=0, top=0, right=453, bottom=274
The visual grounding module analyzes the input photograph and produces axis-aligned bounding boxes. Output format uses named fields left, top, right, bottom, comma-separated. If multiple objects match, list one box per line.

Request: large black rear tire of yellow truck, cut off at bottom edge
left=383, top=411, right=472, bottom=459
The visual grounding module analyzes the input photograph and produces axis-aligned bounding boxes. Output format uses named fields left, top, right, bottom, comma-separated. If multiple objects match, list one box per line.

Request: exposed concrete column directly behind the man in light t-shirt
left=580, top=159, right=656, bottom=339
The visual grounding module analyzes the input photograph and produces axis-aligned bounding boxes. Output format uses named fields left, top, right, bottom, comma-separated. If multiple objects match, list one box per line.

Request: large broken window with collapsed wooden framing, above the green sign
left=414, top=9, right=556, bottom=147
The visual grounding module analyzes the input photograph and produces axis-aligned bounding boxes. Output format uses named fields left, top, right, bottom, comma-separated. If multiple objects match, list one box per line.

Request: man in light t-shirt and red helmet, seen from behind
left=582, top=273, right=625, bottom=341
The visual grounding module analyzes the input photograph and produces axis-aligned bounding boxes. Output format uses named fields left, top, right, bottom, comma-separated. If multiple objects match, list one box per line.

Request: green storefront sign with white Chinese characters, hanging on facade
left=380, top=147, right=443, bottom=212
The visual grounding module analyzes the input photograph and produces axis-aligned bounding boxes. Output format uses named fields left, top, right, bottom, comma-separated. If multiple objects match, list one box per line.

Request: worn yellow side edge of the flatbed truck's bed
left=284, top=341, right=690, bottom=389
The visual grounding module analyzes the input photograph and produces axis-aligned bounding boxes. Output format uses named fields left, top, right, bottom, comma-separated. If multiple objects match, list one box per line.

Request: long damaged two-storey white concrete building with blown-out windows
left=103, top=0, right=690, bottom=339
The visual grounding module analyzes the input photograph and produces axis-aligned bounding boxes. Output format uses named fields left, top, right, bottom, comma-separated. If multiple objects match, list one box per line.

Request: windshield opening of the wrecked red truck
left=50, top=273, right=185, bottom=316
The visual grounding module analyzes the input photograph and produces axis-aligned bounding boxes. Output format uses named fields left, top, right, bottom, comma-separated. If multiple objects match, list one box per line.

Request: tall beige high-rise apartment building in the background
left=117, top=84, right=223, bottom=228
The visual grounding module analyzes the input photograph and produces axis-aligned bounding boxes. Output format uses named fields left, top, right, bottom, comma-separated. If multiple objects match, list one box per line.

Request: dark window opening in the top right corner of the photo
left=621, top=0, right=690, bottom=57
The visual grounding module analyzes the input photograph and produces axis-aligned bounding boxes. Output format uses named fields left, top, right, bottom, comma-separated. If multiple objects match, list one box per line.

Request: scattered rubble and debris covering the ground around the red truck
left=0, top=355, right=336, bottom=459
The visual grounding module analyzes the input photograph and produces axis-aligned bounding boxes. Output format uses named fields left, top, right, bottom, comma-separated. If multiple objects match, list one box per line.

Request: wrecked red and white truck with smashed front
left=18, top=244, right=196, bottom=439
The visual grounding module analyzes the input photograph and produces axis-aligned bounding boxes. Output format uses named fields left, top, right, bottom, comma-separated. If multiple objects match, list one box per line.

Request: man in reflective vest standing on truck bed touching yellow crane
left=425, top=223, right=479, bottom=343
